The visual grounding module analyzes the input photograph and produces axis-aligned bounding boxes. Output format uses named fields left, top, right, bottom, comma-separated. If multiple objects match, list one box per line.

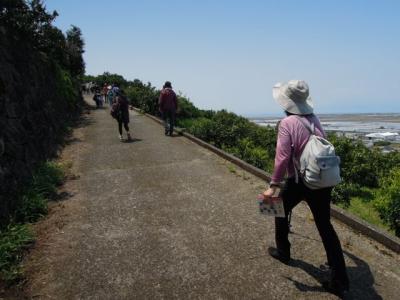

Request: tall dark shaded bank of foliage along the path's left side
left=0, top=0, right=85, bottom=282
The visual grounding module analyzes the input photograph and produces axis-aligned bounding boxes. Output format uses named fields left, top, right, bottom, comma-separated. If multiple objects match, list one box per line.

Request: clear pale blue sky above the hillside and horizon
left=45, top=0, right=400, bottom=115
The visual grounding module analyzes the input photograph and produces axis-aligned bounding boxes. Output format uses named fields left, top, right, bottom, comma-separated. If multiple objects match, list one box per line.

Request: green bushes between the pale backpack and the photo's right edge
left=329, top=135, right=400, bottom=236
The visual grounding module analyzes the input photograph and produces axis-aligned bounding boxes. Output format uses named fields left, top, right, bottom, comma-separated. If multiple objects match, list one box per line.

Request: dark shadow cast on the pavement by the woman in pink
left=286, top=251, right=382, bottom=299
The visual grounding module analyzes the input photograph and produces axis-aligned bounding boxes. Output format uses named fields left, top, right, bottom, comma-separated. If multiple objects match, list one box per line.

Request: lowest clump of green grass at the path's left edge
left=0, top=224, right=34, bottom=283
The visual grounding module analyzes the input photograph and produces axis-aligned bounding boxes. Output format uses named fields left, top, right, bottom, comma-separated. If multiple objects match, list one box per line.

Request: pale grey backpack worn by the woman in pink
left=293, top=116, right=342, bottom=190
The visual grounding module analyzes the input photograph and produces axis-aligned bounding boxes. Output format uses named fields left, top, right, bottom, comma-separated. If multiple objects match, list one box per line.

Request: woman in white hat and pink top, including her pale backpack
left=264, top=80, right=349, bottom=295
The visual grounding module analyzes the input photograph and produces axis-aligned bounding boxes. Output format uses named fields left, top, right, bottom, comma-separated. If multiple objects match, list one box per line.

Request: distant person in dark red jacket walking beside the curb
left=158, top=81, right=178, bottom=136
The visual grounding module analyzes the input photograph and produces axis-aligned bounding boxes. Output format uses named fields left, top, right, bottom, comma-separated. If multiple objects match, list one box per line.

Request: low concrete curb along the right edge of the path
left=132, top=107, right=400, bottom=253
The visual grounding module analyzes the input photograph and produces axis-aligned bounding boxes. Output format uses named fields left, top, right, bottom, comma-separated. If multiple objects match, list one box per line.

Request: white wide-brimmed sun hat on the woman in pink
left=272, top=80, right=314, bottom=115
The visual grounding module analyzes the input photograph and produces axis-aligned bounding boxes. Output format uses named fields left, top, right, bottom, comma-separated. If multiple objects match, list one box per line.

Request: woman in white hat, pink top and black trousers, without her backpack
left=264, top=80, right=349, bottom=294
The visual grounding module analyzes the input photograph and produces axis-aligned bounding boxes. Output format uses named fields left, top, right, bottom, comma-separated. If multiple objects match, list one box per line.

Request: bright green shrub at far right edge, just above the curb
left=375, top=166, right=400, bottom=236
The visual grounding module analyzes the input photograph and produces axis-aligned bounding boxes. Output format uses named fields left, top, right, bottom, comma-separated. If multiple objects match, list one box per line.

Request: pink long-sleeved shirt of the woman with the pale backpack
left=271, top=115, right=325, bottom=184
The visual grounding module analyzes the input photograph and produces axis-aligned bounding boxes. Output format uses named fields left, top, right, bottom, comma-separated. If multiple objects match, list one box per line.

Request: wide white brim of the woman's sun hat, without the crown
left=272, top=83, right=314, bottom=115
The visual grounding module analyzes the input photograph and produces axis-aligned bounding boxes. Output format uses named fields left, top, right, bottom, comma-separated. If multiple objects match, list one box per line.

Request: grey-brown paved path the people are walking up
left=25, top=95, right=400, bottom=299
